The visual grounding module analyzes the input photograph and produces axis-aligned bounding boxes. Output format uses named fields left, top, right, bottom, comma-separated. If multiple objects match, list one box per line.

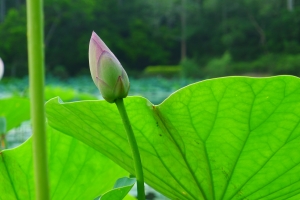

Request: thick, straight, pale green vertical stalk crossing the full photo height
left=27, top=0, right=49, bottom=200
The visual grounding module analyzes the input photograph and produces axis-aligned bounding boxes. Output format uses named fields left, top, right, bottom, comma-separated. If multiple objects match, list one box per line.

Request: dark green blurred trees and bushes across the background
left=0, top=0, right=300, bottom=78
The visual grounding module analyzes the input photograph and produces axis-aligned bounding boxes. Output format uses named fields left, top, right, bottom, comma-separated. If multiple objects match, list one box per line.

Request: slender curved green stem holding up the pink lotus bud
left=115, top=99, right=145, bottom=200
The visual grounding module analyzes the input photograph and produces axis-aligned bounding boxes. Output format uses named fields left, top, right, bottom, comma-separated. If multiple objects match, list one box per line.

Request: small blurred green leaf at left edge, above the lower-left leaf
left=0, top=97, right=30, bottom=131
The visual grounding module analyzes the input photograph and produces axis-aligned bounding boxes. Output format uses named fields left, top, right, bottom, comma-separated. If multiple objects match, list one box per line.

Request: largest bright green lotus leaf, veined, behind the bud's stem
left=46, top=76, right=300, bottom=199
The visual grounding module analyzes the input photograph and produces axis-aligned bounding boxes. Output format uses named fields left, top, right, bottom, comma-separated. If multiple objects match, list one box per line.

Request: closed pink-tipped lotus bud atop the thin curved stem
left=89, top=32, right=129, bottom=103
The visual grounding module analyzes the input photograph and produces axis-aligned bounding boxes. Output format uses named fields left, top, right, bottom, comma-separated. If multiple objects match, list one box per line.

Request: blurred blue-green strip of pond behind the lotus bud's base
left=0, top=76, right=196, bottom=104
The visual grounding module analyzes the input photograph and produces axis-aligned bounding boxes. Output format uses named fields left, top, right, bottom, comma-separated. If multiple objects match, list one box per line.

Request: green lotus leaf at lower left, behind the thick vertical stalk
left=0, top=125, right=128, bottom=200
